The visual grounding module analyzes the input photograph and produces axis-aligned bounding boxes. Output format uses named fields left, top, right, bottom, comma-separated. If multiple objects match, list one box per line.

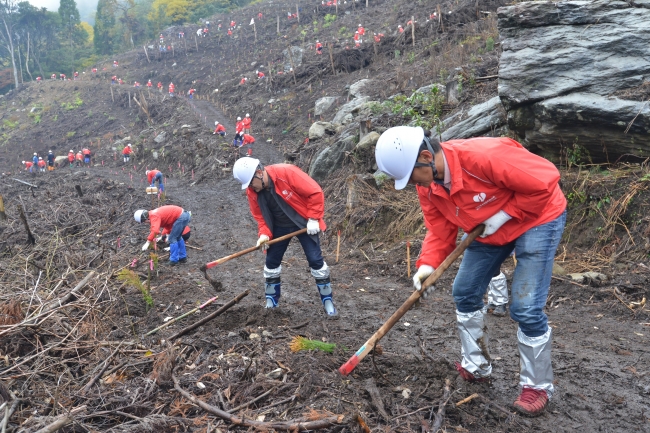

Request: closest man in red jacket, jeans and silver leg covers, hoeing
left=375, top=126, right=566, bottom=416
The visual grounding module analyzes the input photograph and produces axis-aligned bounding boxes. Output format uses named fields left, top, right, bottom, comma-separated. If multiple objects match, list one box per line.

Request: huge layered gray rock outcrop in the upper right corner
left=498, top=0, right=650, bottom=161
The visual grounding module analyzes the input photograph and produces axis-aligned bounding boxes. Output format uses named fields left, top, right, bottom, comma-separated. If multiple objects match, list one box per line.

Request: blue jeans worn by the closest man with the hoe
left=452, top=211, right=566, bottom=337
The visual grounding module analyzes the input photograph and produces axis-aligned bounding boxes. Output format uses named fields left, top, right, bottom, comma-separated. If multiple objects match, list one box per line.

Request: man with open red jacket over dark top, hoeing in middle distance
left=233, top=157, right=338, bottom=316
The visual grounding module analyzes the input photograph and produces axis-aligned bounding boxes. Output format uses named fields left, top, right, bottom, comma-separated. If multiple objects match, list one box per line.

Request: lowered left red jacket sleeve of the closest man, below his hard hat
left=415, top=187, right=458, bottom=268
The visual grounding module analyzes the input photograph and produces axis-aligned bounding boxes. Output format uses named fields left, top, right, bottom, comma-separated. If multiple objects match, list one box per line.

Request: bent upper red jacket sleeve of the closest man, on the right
left=477, top=138, right=560, bottom=222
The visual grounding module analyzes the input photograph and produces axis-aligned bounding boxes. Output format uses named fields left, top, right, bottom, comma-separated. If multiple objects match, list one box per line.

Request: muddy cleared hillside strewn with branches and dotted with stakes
left=0, top=0, right=650, bottom=433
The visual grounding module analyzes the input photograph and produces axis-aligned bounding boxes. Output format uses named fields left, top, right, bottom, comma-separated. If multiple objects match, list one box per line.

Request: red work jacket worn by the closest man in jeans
left=416, top=137, right=566, bottom=268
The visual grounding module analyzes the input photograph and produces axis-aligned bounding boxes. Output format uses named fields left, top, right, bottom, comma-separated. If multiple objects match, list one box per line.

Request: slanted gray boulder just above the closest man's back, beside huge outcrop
left=442, top=96, right=508, bottom=141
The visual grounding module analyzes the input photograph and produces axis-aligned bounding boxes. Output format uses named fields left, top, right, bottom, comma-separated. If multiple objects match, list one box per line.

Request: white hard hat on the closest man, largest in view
left=375, top=126, right=424, bottom=190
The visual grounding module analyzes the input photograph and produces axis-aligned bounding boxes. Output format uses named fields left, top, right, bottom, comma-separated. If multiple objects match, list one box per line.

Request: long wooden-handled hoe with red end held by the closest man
left=339, top=224, right=485, bottom=376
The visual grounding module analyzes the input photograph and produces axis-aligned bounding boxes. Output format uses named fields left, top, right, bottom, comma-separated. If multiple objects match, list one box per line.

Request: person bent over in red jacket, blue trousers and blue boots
left=133, top=205, right=191, bottom=266
